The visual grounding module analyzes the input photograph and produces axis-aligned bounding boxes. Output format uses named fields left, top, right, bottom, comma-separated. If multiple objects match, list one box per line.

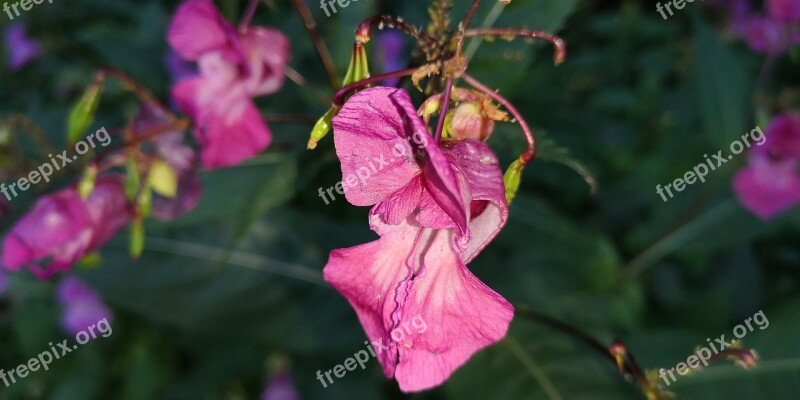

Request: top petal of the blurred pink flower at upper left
left=167, top=0, right=235, bottom=61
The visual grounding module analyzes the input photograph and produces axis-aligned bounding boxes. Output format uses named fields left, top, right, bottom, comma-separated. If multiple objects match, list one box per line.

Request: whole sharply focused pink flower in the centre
left=323, top=87, right=513, bottom=391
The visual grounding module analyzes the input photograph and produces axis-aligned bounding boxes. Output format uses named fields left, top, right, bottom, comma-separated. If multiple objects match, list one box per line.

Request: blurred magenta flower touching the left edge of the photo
left=2, top=176, right=131, bottom=279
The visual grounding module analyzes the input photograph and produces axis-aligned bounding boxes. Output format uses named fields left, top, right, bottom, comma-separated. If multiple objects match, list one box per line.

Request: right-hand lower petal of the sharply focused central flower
left=388, top=230, right=514, bottom=392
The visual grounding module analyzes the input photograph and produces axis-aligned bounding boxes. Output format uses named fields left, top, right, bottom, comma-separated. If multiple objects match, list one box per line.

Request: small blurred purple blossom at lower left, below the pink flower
left=57, top=276, right=113, bottom=335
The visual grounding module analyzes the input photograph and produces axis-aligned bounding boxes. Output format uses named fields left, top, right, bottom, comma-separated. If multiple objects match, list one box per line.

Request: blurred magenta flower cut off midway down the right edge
left=733, top=114, right=800, bottom=220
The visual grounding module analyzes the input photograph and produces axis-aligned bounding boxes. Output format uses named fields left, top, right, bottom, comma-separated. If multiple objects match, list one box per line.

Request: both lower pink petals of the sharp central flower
left=323, top=219, right=513, bottom=391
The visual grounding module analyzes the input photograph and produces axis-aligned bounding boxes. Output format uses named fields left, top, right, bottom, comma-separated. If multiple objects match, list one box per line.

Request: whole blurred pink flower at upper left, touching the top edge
left=167, top=0, right=289, bottom=169
